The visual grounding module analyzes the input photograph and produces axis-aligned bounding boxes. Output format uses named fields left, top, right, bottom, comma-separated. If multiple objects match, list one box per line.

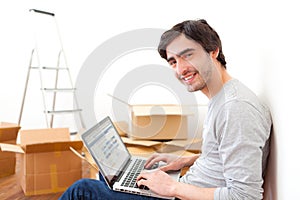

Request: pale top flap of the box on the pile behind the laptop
left=131, top=105, right=193, bottom=116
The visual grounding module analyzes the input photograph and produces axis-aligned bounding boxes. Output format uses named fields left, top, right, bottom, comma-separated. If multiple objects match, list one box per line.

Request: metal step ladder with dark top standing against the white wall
left=18, top=9, right=85, bottom=134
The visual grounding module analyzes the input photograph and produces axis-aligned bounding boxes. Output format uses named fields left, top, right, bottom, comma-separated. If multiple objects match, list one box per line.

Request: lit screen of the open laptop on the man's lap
left=82, top=117, right=130, bottom=184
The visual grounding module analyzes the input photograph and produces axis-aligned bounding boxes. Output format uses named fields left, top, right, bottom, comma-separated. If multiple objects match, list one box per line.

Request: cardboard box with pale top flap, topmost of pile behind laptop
left=129, top=105, right=192, bottom=140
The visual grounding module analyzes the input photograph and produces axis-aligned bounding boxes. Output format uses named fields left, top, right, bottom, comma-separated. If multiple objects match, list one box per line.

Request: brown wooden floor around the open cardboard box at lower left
left=0, top=154, right=90, bottom=200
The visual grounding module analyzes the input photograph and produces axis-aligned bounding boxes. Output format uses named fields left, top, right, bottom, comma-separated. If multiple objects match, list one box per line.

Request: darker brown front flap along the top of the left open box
left=24, top=141, right=83, bottom=153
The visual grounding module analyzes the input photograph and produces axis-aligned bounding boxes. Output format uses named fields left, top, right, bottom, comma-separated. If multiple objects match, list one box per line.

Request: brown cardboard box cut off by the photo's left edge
left=0, top=122, right=20, bottom=178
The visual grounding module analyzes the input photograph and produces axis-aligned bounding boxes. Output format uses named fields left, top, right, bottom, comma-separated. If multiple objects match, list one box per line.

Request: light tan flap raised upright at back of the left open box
left=19, top=128, right=70, bottom=146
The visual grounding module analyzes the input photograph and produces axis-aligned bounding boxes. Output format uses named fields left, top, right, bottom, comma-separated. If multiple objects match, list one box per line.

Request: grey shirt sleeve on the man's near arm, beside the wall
left=214, top=101, right=269, bottom=200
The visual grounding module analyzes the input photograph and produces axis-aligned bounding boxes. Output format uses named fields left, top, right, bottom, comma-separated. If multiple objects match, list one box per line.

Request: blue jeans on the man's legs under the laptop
left=59, top=176, right=164, bottom=200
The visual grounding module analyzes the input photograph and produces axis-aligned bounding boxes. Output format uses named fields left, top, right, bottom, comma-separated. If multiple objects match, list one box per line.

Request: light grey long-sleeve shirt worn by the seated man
left=180, top=79, right=272, bottom=200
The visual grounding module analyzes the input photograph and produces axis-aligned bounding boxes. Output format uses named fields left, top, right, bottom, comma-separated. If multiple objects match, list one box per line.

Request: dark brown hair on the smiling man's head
left=158, top=19, right=226, bottom=69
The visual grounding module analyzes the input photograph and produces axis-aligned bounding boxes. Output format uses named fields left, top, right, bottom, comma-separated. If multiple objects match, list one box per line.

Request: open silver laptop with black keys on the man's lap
left=81, top=116, right=180, bottom=199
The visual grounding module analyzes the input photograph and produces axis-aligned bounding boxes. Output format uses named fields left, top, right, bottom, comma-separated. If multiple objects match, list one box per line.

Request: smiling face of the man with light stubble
left=166, top=34, right=212, bottom=92
